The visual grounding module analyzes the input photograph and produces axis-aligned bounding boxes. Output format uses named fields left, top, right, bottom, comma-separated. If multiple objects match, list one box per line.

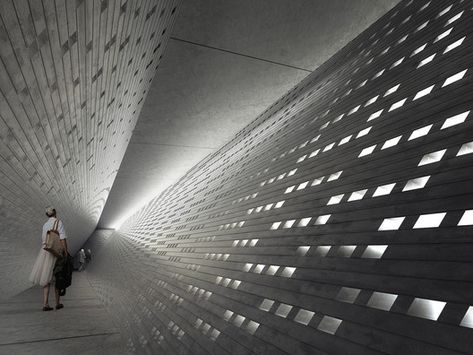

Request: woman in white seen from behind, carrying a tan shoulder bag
left=30, top=207, right=68, bottom=311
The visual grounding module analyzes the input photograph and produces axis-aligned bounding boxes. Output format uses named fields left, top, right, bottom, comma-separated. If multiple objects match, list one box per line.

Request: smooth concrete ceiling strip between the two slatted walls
left=99, top=0, right=398, bottom=228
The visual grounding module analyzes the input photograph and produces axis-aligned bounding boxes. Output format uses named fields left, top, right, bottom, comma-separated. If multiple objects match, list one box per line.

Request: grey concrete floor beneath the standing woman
left=0, top=271, right=127, bottom=355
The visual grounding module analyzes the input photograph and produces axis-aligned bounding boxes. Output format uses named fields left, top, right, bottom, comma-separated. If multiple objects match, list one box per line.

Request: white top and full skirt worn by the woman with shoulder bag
left=30, top=217, right=66, bottom=286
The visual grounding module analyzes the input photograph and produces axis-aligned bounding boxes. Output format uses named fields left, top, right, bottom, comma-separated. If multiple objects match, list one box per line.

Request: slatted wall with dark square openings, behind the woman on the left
left=0, top=0, right=176, bottom=297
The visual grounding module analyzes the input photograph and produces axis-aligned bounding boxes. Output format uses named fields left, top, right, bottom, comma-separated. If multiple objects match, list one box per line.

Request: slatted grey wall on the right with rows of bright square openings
left=87, top=1, right=473, bottom=355
